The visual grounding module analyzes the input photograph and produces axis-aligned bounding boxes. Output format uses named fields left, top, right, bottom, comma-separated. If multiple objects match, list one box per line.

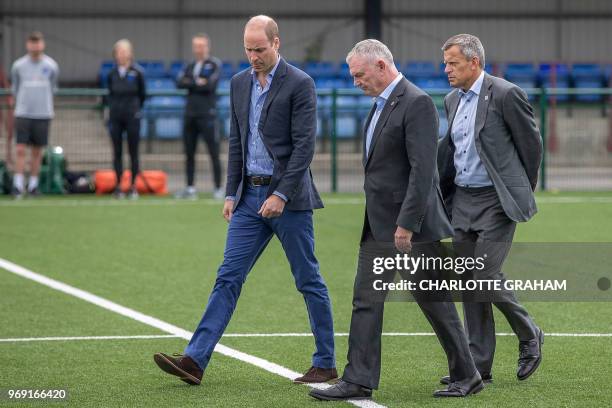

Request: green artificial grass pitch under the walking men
left=0, top=193, right=612, bottom=407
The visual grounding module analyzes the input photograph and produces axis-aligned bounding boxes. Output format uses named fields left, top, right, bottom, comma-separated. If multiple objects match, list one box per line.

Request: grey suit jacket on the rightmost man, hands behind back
left=438, top=73, right=542, bottom=222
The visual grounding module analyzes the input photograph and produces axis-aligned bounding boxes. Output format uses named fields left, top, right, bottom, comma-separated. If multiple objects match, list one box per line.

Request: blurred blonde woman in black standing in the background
left=108, top=39, right=146, bottom=199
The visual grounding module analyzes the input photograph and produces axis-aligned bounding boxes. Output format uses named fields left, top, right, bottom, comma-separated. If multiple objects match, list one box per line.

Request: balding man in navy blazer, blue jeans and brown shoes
left=154, top=16, right=337, bottom=385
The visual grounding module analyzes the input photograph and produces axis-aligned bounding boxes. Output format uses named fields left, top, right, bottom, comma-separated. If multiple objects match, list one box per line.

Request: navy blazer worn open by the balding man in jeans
left=226, top=58, right=323, bottom=211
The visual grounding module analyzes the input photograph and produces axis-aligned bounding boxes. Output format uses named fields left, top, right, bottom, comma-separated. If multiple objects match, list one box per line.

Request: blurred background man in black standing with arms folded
left=176, top=34, right=225, bottom=199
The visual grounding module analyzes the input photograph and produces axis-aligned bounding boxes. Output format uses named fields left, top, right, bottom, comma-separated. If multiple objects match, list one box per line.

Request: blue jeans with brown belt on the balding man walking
left=184, top=186, right=336, bottom=369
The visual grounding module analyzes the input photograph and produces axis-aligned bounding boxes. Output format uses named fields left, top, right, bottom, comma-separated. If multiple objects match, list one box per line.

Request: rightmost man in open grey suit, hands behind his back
left=438, top=34, right=543, bottom=383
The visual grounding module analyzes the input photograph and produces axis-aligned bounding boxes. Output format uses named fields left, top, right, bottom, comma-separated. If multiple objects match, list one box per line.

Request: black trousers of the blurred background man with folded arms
left=183, top=115, right=221, bottom=188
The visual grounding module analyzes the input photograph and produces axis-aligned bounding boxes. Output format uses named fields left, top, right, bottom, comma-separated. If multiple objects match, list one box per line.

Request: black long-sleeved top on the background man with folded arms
left=176, top=57, right=221, bottom=117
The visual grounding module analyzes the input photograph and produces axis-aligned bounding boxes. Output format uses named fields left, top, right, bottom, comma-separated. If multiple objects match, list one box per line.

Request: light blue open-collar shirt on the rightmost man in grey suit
left=451, top=71, right=493, bottom=187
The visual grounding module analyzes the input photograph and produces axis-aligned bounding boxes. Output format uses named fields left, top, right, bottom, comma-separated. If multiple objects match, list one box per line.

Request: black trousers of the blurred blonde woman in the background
left=108, top=115, right=140, bottom=185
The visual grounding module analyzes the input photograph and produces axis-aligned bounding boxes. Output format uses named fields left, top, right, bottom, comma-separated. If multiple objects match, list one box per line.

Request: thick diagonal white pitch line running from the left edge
left=0, top=258, right=386, bottom=408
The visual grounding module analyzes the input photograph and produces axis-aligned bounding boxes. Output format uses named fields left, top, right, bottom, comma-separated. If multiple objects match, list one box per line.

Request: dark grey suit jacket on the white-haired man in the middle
left=362, top=79, right=452, bottom=242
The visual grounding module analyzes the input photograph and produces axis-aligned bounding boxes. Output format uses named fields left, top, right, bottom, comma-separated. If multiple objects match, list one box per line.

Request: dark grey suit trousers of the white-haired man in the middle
left=342, top=234, right=476, bottom=389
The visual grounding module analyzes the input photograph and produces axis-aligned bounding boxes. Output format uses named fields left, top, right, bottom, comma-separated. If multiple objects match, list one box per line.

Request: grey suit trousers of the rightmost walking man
left=452, top=187, right=538, bottom=374
